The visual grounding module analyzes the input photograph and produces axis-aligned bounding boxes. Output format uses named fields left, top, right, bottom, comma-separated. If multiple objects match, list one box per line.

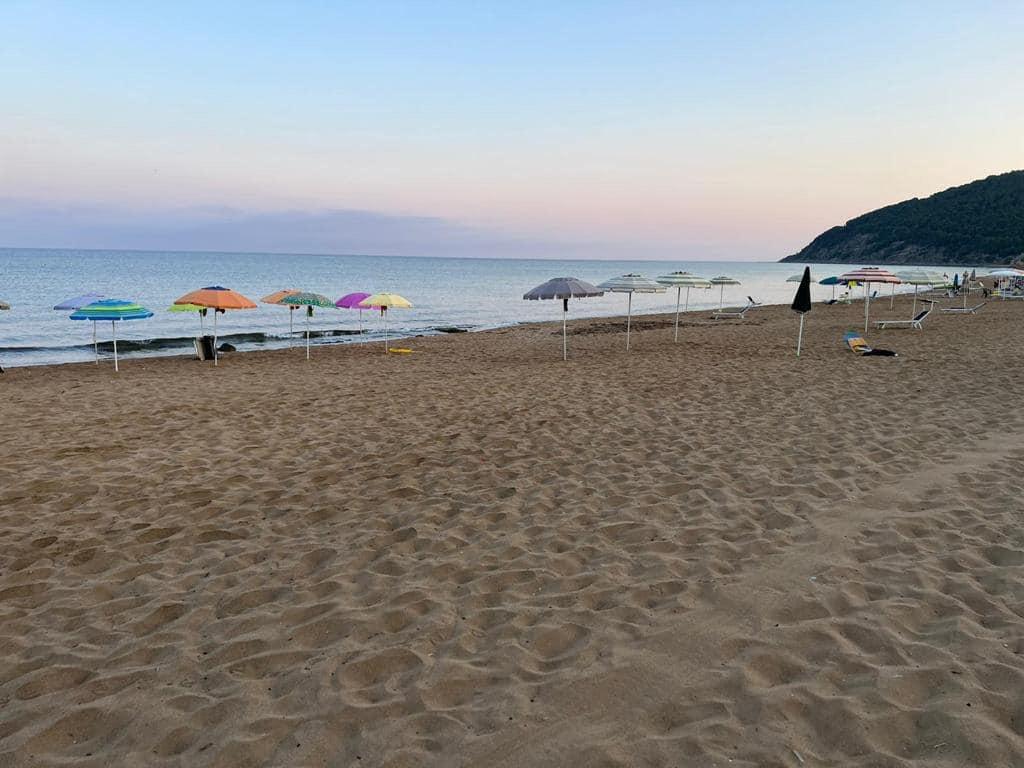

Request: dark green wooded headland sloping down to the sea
left=782, top=171, right=1024, bottom=265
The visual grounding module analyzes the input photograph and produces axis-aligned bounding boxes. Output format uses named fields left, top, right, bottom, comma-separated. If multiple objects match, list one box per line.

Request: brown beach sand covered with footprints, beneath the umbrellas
left=0, top=290, right=1024, bottom=768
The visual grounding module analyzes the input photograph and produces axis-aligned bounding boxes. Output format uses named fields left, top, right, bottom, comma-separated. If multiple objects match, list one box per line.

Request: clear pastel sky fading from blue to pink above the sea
left=0, top=0, right=1024, bottom=260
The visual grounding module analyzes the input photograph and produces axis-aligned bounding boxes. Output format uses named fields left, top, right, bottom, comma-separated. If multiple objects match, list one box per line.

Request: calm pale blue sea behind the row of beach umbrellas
left=0, top=248, right=950, bottom=367
